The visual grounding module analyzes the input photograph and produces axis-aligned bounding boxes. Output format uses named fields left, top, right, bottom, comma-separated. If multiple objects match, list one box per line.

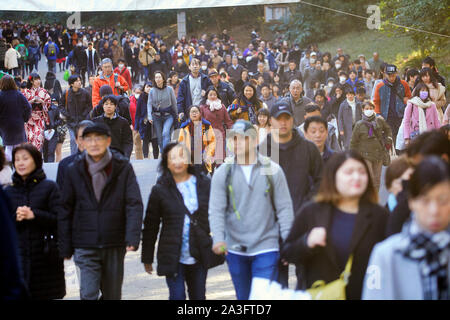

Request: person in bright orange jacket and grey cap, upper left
left=92, top=58, right=129, bottom=106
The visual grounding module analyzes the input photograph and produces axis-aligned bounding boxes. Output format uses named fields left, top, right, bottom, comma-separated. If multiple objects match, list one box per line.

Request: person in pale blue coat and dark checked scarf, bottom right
left=363, top=156, right=450, bottom=300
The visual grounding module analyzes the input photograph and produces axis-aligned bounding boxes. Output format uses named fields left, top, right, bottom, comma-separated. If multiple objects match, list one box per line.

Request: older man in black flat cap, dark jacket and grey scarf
left=58, top=124, right=143, bottom=300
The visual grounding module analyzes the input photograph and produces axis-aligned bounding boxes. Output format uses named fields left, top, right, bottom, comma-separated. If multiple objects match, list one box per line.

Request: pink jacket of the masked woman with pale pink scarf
left=403, top=102, right=441, bottom=139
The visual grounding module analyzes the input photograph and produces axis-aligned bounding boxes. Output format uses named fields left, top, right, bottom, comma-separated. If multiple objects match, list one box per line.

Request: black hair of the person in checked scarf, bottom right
left=408, top=156, right=450, bottom=198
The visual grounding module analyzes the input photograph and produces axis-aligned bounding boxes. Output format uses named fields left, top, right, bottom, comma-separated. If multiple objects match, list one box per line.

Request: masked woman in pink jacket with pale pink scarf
left=403, top=82, right=441, bottom=145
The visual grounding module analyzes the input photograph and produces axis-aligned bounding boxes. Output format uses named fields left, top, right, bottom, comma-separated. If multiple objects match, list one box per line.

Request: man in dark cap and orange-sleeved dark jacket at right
left=373, top=64, right=411, bottom=146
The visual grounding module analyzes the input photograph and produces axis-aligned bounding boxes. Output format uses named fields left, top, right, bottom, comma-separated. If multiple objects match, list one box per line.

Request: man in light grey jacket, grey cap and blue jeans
left=209, top=120, right=294, bottom=300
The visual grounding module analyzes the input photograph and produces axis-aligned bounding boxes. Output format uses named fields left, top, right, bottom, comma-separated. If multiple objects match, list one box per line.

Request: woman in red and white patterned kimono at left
left=24, top=73, right=51, bottom=150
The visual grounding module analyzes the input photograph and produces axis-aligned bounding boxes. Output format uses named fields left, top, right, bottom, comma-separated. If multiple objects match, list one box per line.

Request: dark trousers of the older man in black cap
left=73, top=247, right=126, bottom=300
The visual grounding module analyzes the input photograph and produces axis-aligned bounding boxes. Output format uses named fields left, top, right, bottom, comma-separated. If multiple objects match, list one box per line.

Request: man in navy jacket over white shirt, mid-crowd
left=177, top=58, right=211, bottom=122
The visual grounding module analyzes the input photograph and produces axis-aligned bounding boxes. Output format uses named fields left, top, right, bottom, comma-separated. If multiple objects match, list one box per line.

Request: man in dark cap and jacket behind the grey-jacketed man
left=259, top=100, right=323, bottom=287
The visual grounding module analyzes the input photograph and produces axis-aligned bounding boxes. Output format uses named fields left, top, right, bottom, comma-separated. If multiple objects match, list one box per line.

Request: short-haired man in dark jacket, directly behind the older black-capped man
left=59, top=75, right=92, bottom=155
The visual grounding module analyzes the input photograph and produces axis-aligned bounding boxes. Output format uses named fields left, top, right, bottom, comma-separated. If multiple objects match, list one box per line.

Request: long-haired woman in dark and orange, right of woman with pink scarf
left=228, top=82, right=263, bottom=124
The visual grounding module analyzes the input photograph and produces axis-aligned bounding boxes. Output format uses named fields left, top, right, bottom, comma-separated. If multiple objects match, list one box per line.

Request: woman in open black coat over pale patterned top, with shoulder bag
left=142, top=142, right=217, bottom=300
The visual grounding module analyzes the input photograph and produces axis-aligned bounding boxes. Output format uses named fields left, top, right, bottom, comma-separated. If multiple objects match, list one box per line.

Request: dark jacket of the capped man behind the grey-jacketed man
left=259, top=129, right=323, bottom=215
